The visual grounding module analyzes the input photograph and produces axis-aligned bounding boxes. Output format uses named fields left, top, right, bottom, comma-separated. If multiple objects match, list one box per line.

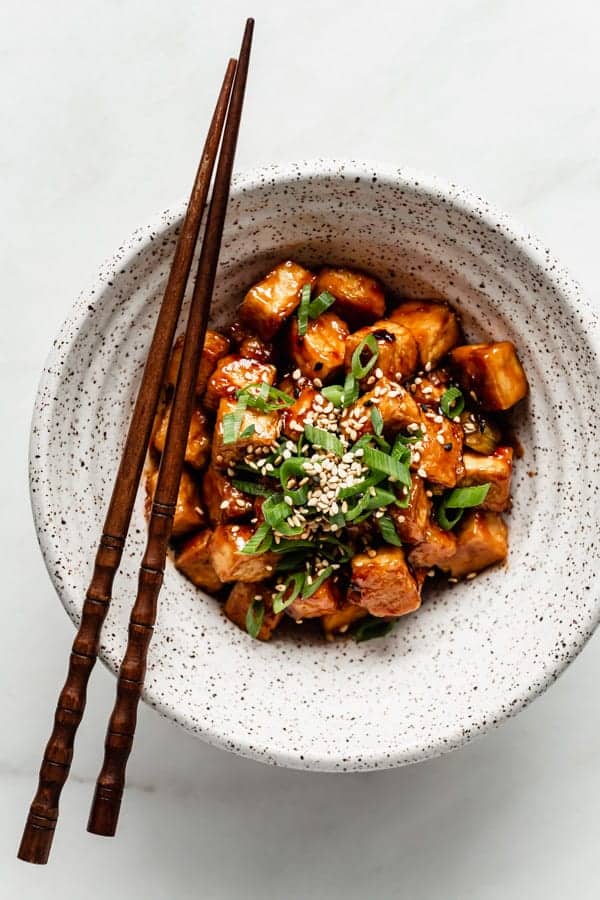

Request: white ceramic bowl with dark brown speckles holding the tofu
left=31, top=160, right=600, bottom=771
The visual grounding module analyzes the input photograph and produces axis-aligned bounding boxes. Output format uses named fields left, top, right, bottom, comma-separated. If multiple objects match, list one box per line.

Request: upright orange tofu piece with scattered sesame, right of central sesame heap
left=418, top=414, right=464, bottom=487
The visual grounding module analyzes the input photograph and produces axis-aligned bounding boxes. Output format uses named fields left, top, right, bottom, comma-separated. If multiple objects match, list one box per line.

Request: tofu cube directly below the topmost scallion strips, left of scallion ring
left=288, top=312, right=350, bottom=381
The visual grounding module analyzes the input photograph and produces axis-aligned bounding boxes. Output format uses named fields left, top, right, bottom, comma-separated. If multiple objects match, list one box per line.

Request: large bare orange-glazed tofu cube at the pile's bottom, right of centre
left=348, top=547, right=421, bottom=616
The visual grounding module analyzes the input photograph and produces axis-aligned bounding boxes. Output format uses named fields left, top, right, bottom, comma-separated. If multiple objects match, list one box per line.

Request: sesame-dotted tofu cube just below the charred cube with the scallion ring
left=341, top=378, right=423, bottom=440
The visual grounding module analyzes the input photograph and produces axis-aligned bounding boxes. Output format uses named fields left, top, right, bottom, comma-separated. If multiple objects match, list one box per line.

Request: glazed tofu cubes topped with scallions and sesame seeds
left=147, top=261, right=528, bottom=640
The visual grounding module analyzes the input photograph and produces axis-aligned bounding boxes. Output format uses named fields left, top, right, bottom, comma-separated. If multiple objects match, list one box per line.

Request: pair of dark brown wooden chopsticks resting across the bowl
left=18, top=19, right=254, bottom=864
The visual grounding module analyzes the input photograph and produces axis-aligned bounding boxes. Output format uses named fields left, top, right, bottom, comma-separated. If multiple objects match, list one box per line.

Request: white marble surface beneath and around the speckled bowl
left=0, top=0, right=600, bottom=900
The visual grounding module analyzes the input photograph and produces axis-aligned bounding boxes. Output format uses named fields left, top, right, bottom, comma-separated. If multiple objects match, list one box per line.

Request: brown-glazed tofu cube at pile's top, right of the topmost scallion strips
left=316, top=268, right=385, bottom=328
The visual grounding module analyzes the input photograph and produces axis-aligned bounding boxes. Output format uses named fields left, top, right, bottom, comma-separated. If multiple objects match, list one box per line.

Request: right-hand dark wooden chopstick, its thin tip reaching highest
left=88, top=19, right=254, bottom=837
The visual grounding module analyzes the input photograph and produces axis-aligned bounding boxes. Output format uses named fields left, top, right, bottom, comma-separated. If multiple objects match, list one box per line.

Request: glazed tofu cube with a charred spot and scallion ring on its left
left=344, top=319, right=417, bottom=384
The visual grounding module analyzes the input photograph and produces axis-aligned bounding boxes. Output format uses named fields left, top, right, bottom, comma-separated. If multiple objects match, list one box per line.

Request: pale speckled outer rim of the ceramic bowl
left=29, top=158, right=600, bottom=771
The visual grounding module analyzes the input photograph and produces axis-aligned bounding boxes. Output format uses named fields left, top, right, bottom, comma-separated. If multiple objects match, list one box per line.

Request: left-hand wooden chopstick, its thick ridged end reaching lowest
left=18, top=59, right=236, bottom=864
